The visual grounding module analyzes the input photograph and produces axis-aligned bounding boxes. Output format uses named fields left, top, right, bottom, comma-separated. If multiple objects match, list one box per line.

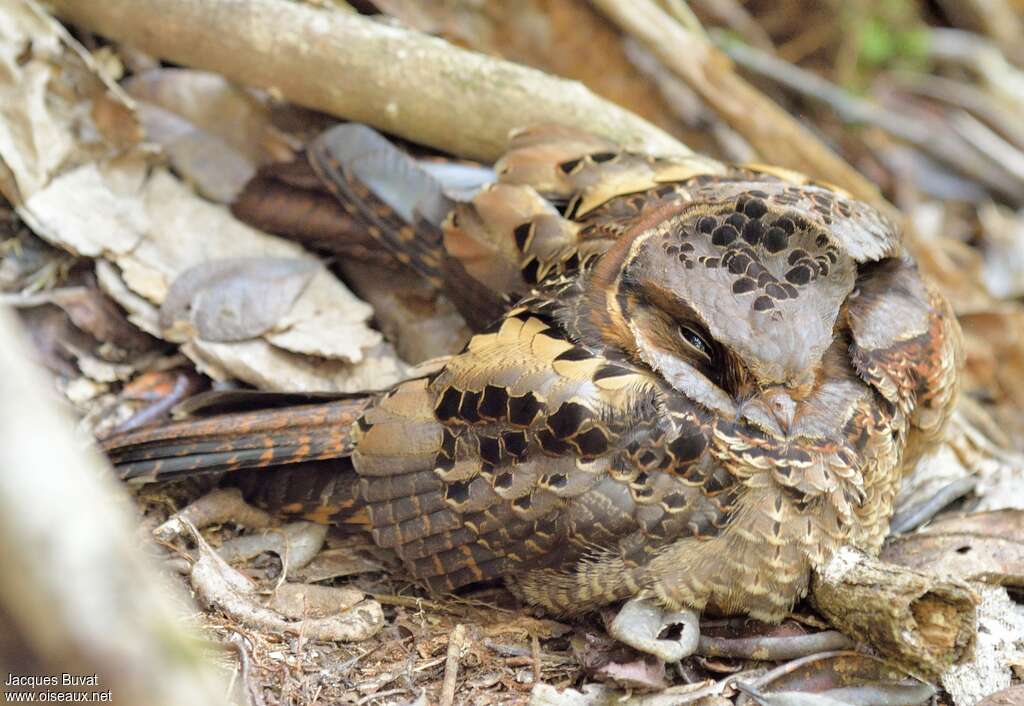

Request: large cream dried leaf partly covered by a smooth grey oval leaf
left=91, top=170, right=407, bottom=391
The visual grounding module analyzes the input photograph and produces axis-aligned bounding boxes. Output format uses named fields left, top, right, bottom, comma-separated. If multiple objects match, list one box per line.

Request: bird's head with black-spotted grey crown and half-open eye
left=589, top=180, right=886, bottom=435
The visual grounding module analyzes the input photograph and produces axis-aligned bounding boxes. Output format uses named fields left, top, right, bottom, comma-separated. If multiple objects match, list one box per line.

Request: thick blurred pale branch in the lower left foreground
left=0, top=308, right=225, bottom=706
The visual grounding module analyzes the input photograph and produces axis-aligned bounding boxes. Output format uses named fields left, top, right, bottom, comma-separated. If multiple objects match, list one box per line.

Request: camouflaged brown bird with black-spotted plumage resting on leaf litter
left=105, top=126, right=962, bottom=651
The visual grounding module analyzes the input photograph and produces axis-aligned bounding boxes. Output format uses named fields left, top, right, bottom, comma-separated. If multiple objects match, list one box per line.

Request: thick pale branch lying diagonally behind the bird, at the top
left=49, top=0, right=689, bottom=161
